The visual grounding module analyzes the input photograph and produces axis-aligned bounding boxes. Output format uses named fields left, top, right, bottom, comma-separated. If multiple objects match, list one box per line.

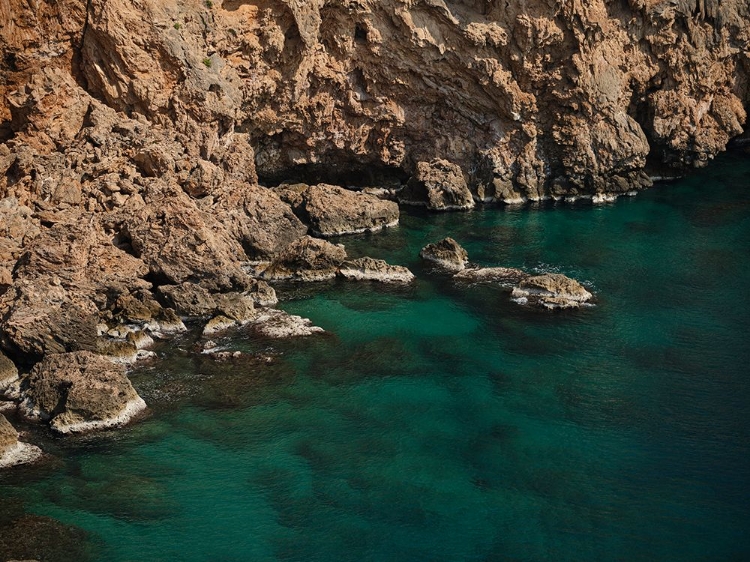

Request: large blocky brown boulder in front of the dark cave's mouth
left=286, top=184, right=399, bottom=236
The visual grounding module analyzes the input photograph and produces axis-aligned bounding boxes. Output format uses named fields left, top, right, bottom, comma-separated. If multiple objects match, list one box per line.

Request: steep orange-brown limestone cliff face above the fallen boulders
left=0, top=0, right=750, bottom=200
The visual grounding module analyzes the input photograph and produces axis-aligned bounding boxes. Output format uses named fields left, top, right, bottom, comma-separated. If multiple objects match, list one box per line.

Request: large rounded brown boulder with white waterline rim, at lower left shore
left=19, top=351, right=146, bottom=433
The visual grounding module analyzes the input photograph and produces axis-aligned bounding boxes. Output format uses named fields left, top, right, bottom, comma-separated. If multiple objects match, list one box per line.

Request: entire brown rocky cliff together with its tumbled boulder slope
left=0, top=0, right=750, bottom=440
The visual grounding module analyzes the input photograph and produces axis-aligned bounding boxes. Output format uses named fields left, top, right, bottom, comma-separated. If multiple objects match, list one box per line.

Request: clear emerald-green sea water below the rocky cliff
left=0, top=151, right=750, bottom=562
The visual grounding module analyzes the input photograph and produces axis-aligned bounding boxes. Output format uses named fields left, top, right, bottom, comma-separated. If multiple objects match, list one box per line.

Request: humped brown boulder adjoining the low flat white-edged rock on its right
left=262, top=236, right=346, bottom=281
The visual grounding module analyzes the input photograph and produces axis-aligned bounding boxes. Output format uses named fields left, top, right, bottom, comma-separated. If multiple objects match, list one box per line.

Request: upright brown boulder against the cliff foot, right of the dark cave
left=398, top=159, right=474, bottom=211
